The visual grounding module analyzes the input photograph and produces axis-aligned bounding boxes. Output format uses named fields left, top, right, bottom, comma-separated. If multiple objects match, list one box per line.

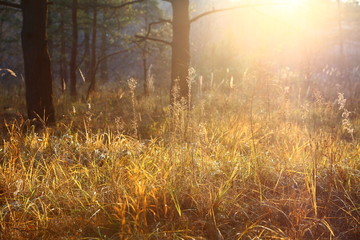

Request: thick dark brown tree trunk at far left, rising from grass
left=21, top=0, right=55, bottom=124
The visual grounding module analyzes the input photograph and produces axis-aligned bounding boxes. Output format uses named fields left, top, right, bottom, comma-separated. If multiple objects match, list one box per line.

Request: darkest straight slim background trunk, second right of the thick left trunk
left=70, top=0, right=78, bottom=100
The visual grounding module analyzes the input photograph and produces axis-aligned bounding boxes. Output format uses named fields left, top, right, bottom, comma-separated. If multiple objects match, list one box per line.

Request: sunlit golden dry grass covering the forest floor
left=0, top=76, right=360, bottom=240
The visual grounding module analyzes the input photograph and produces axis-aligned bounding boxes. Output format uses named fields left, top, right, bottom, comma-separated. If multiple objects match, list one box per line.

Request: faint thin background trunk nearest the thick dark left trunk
left=59, top=9, right=67, bottom=92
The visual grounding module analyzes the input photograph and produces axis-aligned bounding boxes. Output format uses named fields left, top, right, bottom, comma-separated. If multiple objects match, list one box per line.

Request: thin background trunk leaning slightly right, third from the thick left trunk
left=87, top=4, right=97, bottom=98
